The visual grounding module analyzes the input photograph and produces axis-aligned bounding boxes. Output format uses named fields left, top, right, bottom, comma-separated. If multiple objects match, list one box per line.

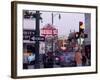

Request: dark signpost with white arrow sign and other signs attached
left=23, top=11, right=44, bottom=68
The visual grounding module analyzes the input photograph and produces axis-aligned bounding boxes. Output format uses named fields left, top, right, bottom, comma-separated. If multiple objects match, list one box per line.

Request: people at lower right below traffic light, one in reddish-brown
left=75, top=44, right=90, bottom=66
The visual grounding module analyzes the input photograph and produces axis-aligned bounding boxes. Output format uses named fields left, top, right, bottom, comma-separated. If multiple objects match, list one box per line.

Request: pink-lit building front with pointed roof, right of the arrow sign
left=40, top=24, right=58, bottom=53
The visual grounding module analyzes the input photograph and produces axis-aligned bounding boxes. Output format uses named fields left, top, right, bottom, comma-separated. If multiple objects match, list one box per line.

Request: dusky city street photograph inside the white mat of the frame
left=23, top=10, right=91, bottom=69
